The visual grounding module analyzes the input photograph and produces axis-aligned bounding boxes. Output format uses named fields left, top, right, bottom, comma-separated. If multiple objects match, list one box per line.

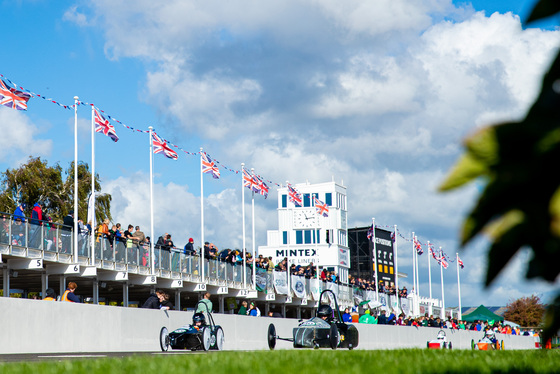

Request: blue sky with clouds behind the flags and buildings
left=0, top=0, right=560, bottom=306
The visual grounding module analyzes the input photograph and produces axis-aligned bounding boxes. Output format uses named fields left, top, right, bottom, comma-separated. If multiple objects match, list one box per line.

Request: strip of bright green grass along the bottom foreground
left=0, top=349, right=560, bottom=374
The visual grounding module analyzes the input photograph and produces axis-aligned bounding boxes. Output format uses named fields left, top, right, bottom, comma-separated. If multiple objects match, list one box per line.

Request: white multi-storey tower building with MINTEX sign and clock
left=258, top=182, right=350, bottom=282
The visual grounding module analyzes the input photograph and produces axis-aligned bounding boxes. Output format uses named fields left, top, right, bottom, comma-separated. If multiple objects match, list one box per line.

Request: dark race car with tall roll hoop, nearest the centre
left=267, top=290, right=359, bottom=349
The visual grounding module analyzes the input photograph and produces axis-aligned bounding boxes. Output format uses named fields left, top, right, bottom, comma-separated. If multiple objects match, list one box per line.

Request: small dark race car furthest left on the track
left=159, top=302, right=225, bottom=352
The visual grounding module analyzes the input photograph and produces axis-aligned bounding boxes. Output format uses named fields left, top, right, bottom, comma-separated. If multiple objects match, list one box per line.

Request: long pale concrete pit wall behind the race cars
left=0, top=297, right=535, bottom=354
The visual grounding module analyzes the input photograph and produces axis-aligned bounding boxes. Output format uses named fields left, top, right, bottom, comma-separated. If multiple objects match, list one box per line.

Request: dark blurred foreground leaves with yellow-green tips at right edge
left=440, top=0, right=560, bottom=344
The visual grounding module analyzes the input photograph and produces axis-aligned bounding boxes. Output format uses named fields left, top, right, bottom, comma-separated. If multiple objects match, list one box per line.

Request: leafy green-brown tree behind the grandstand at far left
left=0, top=157, right=111, bottom=222
